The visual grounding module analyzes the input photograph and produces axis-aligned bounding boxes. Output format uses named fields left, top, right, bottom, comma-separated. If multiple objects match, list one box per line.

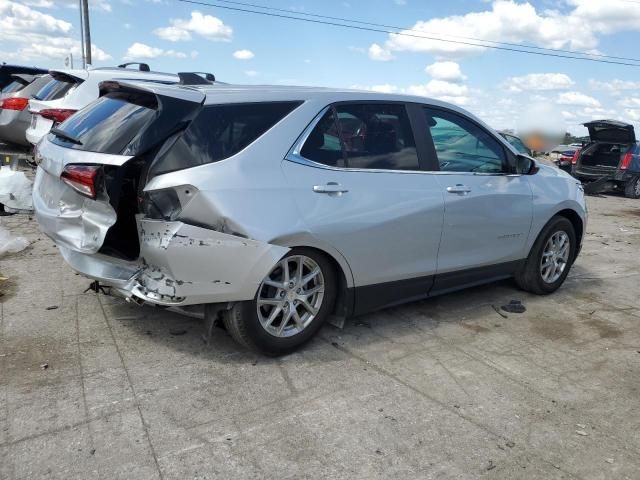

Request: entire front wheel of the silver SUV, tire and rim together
left=515, top=216, right=577, bottom=295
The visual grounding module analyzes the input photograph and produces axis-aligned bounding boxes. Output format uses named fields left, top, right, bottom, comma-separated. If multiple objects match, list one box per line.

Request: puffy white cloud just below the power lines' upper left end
left=153, top=10, right=233, bottom=42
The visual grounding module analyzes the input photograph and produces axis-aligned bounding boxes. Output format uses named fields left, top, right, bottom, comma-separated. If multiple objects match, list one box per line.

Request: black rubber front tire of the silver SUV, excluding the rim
left=515, top=216, right=577, bottom=295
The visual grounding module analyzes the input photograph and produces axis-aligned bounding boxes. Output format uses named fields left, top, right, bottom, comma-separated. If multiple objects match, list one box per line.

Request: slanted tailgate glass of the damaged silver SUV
left=50, top=94, right=156, bottom=154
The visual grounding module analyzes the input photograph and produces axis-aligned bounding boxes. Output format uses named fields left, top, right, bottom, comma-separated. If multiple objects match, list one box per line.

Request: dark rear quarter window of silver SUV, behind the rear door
left=149, top=102, right=301, bottom=177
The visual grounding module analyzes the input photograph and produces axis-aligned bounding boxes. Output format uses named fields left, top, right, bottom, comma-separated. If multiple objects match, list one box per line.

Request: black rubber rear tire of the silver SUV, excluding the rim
left=222, top=248, right=337, bottom=356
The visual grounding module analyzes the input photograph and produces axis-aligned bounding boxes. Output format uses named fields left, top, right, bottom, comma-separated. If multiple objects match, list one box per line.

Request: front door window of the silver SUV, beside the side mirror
left=424, top=108, right=508, bottom=173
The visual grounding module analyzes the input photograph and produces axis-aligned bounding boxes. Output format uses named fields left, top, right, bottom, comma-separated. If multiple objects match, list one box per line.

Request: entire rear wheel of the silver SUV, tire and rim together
left=223, top=248, right=337, bottom=356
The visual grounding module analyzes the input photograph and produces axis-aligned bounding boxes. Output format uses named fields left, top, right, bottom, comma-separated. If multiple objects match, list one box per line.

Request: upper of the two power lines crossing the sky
left=208, top=0, right=640, bottom=62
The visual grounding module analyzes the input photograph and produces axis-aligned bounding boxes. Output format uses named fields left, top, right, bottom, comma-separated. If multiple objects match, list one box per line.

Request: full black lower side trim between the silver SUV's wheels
left=346, top=259, right=525, bottom=316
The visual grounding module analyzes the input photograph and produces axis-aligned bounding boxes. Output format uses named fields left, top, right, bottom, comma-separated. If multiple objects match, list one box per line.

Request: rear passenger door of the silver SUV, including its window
left=283, top=102, right=443, bottom=310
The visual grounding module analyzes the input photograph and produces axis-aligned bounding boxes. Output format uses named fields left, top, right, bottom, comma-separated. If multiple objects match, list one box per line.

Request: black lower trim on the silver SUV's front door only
left=429, top=259, right=525, bottom=296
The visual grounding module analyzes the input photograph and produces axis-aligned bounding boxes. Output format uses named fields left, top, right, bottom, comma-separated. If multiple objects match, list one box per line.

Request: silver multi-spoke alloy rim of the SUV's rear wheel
left=257, top=255, right=325, bottom=337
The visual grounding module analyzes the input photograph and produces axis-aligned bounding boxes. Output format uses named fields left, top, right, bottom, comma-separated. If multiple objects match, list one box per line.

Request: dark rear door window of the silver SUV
left=300, top=103, right=420, bottom=170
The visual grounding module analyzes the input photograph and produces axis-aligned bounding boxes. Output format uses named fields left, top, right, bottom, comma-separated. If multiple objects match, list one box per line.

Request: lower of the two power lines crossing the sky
left=178, top=0, right=640, bottom=67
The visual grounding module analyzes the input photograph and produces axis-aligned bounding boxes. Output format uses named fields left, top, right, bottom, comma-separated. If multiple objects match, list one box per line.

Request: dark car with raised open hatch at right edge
left=571, top=120, right=640, bottom=198
